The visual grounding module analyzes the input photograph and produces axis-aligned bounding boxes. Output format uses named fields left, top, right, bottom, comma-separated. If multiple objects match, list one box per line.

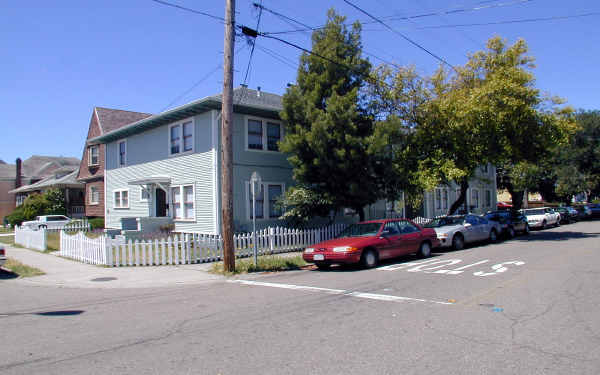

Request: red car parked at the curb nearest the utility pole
left=302, top=219, right=439, bottom=269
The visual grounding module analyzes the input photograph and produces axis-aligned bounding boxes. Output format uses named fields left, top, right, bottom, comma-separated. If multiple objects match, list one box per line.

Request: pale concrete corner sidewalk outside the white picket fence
left=1, top=245, right=225, bottom=288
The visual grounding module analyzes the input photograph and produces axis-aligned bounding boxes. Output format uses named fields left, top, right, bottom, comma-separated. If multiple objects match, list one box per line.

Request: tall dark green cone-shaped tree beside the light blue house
left=280, top=10, right=372, bottom=219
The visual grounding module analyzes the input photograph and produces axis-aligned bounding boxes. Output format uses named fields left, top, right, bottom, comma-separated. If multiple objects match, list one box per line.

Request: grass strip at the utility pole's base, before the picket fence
left=209, top=255, right=308, bottom=276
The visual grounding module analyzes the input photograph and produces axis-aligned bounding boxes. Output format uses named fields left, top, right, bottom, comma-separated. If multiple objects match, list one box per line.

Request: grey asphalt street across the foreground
left=0, top=221, right=600, bottom=375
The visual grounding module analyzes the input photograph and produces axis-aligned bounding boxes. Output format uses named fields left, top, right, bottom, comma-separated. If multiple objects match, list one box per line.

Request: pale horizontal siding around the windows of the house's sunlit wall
left=105, top=112, right=216, bottom=233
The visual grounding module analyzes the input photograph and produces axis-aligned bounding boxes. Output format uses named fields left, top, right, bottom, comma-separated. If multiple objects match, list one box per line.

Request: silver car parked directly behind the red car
left=425, top=214, right=502, bottom=250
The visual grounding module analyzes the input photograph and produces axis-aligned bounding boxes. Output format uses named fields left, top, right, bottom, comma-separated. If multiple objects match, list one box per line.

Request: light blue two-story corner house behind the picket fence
left=89, top=87, right=293, bottom=233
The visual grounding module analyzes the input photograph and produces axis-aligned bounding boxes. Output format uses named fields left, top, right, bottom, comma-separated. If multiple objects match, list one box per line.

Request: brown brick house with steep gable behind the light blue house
left=77, top=107, right=151, bottom=217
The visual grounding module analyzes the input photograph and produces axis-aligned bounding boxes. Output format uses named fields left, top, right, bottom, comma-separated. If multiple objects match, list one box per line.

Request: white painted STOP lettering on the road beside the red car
left=378, top=259, right=525, bottom=276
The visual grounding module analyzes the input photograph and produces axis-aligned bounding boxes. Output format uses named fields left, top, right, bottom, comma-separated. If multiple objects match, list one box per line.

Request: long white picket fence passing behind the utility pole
left=59, top=224, right=346, bottom=267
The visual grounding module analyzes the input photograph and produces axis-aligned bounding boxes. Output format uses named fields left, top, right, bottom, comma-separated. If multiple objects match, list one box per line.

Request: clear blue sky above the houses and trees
left=0, top=0, right=600, bottom=163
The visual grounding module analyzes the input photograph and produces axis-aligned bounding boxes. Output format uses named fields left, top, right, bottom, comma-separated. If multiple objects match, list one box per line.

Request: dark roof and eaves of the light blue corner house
left=88, top=87, right=283, bottom=144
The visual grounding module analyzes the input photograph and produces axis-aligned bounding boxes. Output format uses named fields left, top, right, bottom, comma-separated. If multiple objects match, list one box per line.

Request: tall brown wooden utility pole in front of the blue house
left=221, top=0, right=235, bottom=272
